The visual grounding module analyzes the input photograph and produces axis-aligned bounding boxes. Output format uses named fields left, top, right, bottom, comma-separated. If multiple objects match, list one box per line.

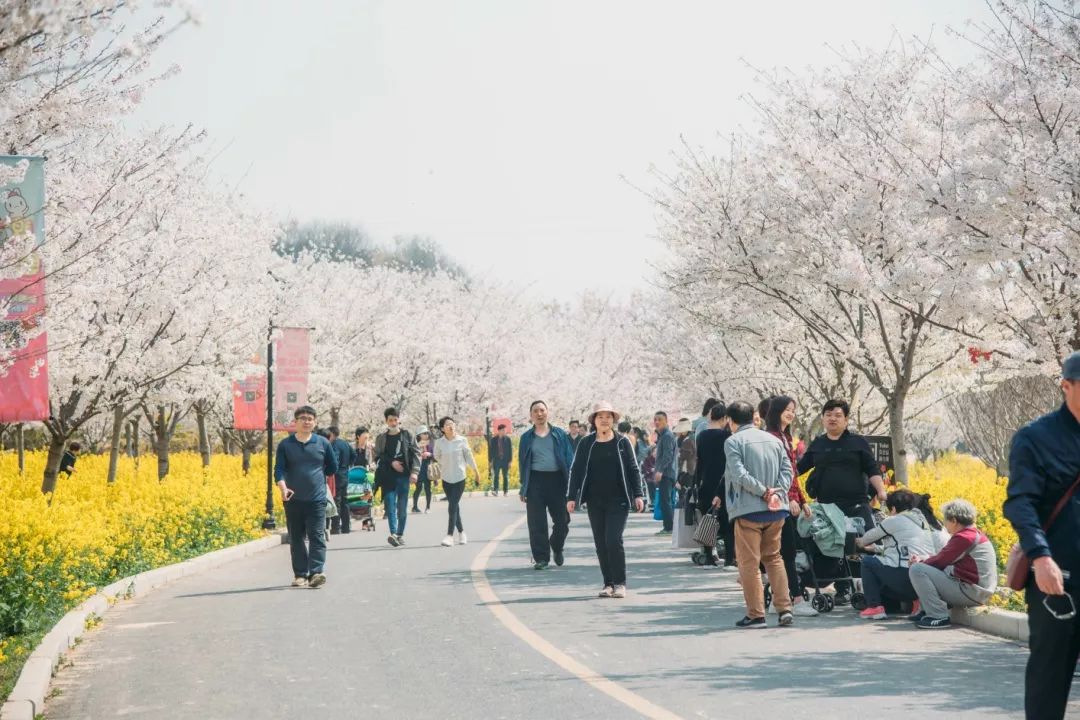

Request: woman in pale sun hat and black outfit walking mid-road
left=566, top=403, right=645, bottom=598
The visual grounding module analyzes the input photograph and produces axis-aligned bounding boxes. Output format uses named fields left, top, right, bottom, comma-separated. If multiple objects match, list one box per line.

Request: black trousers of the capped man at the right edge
left=1024, top=580, right=1080, bottom=720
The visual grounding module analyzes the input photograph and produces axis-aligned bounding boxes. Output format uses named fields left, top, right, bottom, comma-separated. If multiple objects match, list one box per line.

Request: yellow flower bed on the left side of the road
left=0, top=452, right=282, bottom=697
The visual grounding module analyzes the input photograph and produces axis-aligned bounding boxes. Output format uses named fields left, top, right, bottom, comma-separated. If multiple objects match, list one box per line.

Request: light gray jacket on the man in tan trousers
left=724, top=425, right=792, bottom=519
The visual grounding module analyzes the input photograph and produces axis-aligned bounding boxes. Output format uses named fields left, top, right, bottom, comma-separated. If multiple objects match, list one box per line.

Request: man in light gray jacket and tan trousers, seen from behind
left=724, top=402, right=795, bottom=628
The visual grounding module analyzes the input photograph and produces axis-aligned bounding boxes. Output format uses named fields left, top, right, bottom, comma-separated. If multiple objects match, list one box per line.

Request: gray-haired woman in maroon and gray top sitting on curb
left=908, top=500, right=998, bottom=629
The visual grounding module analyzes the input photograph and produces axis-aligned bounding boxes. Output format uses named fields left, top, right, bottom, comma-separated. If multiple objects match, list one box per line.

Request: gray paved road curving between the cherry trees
left=45, top=498, right=1080, bottom=720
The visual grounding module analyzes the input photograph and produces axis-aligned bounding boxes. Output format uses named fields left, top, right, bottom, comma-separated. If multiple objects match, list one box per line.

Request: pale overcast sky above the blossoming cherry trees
left=135, top=0, right=987, bottom=298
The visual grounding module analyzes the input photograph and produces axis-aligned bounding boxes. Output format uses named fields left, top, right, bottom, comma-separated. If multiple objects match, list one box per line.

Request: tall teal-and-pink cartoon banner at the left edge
left=0, top=155, right=49, bottom=422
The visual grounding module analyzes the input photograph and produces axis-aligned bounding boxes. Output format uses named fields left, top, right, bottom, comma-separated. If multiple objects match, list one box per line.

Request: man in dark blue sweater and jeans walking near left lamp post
left=273, top=405, right=337, bottom=587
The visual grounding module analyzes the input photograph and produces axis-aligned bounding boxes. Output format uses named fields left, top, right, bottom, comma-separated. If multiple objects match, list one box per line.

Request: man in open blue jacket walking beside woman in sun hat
left=517, top=400, right=573, bottom=570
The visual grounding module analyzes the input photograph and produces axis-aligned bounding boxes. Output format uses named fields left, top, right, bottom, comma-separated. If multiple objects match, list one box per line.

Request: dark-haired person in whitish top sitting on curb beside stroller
left=855, top=489, right=936, bottom=620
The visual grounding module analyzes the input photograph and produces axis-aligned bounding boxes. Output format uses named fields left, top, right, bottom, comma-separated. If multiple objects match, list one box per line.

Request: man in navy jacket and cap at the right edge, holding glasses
left=1004, top=352, right=1080, bottom=720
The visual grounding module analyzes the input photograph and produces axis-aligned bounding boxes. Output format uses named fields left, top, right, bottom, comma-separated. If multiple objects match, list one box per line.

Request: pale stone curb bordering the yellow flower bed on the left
left=0, top=533, right=285, bottom=720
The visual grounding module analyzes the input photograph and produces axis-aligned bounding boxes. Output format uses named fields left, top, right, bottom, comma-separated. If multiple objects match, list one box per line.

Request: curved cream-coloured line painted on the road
left=472, top=516, right=683, bottom=720
